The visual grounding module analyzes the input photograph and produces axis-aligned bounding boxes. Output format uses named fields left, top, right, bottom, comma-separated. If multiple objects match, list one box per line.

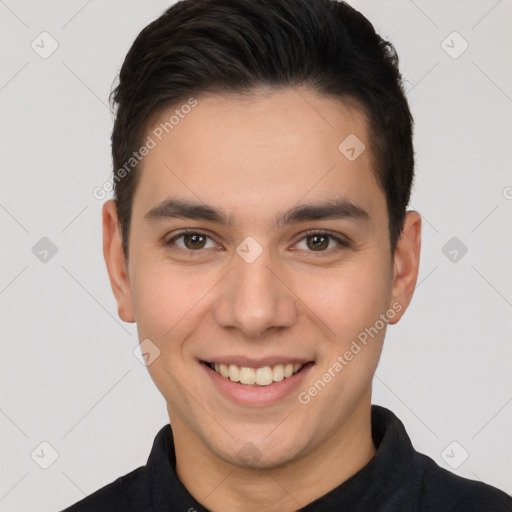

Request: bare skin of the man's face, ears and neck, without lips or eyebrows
left=103, top=89, right=421, bottom=512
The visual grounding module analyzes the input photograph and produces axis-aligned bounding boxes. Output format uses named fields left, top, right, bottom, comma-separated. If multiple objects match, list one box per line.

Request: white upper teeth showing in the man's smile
left=213, top=363, right=302, bottom=386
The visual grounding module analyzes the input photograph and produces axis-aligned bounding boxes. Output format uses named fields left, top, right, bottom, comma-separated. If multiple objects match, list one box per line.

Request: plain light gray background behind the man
left=0, top=0, right=512, bottom=511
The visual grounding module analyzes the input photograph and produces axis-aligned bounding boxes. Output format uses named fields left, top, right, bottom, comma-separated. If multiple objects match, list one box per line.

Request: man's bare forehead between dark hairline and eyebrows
left=136, top=89, right=385, bottom=224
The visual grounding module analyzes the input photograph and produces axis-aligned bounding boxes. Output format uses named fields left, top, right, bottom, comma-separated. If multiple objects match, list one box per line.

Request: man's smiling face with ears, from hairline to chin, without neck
left=104, top=89, right=419, bottom=467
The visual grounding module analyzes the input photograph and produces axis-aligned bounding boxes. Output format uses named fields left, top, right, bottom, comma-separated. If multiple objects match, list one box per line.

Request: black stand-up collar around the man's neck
left=146, top=405, right=423, bottom=512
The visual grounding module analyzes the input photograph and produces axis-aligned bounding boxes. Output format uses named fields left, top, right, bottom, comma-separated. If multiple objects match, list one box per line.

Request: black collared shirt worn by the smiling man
left=63, top=405, right=512, bottom=512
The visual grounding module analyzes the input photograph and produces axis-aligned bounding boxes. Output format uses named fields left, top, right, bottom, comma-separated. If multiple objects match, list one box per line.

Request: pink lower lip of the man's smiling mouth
left=200, top=363, right=314, bottom=406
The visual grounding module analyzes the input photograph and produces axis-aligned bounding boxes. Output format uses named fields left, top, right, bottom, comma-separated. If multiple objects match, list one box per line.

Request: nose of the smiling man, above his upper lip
left=214, top=250, right=298, bottom=339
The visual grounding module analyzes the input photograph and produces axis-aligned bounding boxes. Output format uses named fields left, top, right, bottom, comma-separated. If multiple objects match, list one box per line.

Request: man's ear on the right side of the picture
left=389, top=211, right=421, bottom=324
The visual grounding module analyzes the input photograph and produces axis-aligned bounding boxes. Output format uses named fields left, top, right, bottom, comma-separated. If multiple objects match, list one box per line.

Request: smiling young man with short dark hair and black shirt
left=63, top=0, right=512, bottom=512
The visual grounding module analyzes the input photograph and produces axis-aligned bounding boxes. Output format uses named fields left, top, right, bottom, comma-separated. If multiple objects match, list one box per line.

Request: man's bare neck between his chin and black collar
left=171, top=401, right=376, bottom=512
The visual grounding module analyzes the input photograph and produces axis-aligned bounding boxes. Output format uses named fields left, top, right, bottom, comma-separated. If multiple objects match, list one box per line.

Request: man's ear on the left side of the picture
left=102, top=200, right=135, bottom=322
